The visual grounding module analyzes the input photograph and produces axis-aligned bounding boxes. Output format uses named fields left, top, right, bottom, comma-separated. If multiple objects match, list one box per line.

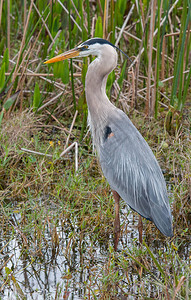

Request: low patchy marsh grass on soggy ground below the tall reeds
left=1, top=111, right=190, bottom=299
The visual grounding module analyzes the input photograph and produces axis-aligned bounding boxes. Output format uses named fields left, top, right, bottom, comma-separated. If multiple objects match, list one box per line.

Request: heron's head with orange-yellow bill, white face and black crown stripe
left=45, top=38, right=127, bottom=64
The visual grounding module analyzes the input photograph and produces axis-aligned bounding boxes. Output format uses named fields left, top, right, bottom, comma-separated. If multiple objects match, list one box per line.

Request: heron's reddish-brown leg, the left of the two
left=112, top=190, right=120, bottom=251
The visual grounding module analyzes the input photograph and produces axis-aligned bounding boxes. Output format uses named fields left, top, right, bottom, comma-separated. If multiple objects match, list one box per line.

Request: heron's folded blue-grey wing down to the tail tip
left=99, top=110, right=173, bottom=236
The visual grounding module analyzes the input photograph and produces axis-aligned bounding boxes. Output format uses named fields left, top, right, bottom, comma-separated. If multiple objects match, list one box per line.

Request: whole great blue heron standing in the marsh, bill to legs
left=45, top=38, right=173, bottom=250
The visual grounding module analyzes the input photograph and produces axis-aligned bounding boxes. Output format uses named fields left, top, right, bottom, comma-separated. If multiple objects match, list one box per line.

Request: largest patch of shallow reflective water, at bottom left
left=0, top=210, right=115, bottom=300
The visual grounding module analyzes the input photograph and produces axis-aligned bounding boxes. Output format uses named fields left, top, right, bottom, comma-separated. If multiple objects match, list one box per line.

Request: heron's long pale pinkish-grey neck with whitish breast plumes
left=86, top=46, right=117, bottom=153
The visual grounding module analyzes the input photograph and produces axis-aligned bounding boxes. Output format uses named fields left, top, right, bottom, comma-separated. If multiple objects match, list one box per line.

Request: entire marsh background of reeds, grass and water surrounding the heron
left=0, top=0, right=191, bottom=300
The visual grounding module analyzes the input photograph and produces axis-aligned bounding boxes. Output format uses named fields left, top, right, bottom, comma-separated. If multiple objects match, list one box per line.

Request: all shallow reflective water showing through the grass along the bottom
left=0, top=199, right=189, bottom=300
